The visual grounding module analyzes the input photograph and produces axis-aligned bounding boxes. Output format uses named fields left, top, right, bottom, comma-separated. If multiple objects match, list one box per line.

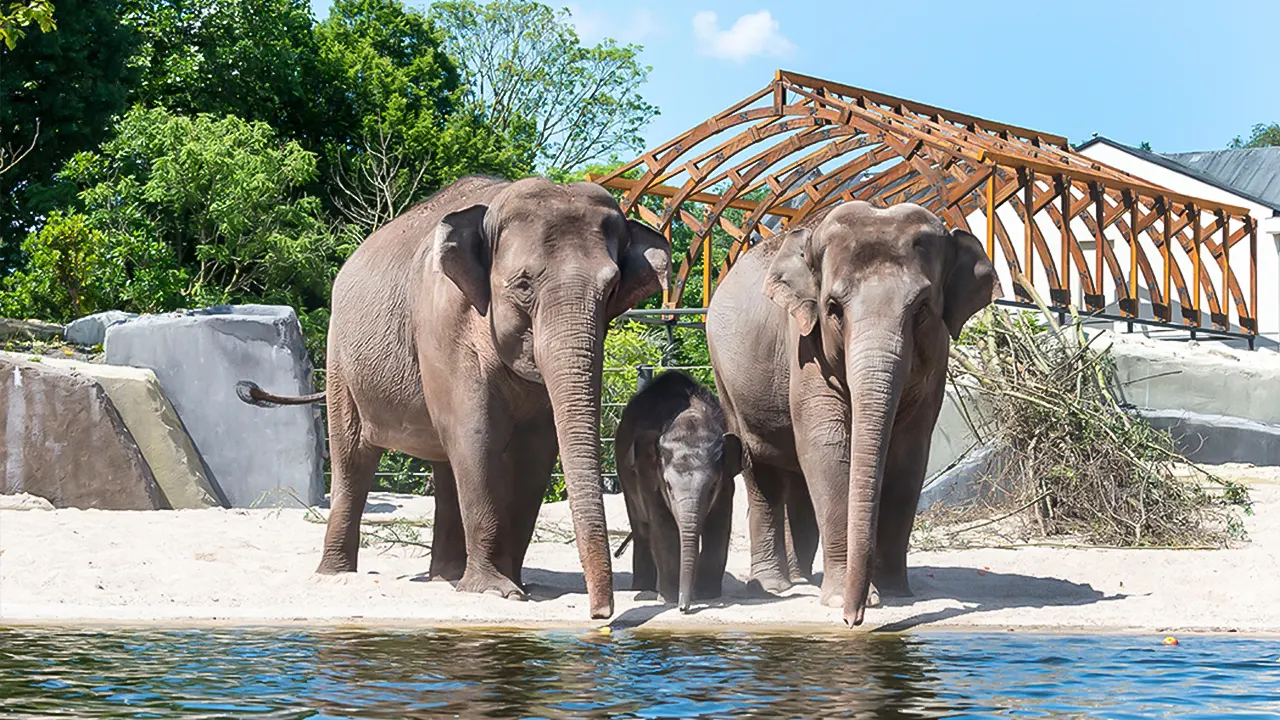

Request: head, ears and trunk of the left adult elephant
left=436, top=178, right=671, bottom=618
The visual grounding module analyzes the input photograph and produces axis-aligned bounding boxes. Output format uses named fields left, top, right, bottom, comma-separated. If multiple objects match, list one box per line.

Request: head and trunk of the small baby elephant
left=654, top=413, right=742, bottom=612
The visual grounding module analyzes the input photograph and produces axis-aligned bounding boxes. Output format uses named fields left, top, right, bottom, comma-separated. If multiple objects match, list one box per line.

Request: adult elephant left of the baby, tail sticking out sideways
left=242, top=177, right=671, bottom=618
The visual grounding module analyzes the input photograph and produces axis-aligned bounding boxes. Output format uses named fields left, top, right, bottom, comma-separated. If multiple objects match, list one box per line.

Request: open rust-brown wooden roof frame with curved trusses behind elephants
left=590, top=70, right=1258, bottom=337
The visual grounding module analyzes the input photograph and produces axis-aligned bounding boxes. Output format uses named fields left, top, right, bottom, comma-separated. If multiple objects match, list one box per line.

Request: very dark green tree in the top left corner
left=0, top=0, right=138, bottom=277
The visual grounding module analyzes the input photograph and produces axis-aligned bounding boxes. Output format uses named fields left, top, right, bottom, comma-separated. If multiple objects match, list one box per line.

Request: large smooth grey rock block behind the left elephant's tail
left=105, top=305, right=324, bottom=507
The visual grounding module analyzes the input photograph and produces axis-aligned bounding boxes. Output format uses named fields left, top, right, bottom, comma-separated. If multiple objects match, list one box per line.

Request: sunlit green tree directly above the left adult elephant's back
left=316, top=0, right=531, bottom=233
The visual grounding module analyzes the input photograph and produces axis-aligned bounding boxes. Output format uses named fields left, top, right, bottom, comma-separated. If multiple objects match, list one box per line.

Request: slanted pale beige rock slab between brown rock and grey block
left=9, top=354, right=223, bottom=510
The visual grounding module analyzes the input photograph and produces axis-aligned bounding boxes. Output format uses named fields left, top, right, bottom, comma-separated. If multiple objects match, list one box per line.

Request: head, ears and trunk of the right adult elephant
left=765, top=201, right=996, bottom=625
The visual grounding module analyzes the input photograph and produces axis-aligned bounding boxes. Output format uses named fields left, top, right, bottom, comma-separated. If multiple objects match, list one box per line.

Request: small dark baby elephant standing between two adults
left=614, top=372, right=742, bottom=612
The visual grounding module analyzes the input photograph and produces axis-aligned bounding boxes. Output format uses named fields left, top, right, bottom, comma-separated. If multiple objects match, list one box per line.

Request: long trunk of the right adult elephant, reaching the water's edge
left=844, top=323, right=909, bottom=626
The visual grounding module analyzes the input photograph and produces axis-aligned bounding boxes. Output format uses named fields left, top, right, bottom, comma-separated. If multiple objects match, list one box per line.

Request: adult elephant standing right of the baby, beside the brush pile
left=707, top=202, right=995, bottom=625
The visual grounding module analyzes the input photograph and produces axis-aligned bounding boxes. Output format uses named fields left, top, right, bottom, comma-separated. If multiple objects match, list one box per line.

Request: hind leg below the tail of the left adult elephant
left=316, top=370, right=383, bottom=575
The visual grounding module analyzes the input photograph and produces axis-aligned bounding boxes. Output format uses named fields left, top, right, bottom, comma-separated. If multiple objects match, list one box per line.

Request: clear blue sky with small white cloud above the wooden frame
left=312, top=0, right=1280, bottom=152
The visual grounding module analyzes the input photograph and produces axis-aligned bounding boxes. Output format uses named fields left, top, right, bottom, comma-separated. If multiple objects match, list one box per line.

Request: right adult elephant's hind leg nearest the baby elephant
left=742, top=452, right=791, bottom=593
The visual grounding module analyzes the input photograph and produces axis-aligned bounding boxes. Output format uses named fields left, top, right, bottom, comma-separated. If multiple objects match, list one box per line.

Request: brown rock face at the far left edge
left=0, top=355, right=166, bottom=510
